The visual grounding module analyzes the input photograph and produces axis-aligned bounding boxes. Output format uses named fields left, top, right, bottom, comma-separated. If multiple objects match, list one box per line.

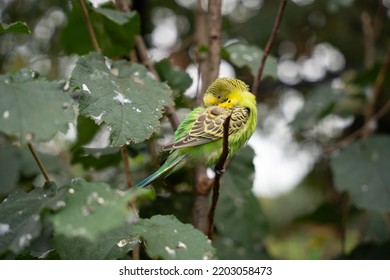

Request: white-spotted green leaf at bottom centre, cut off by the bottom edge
left=133, top=215, right=215, bottom=260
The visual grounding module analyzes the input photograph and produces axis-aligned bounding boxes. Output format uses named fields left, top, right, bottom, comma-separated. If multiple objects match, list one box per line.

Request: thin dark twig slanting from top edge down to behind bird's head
left=252, top=0, right=287, bottom=95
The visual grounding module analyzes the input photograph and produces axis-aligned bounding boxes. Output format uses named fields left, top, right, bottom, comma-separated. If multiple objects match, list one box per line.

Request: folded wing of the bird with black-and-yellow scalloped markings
left=162, top=106, right=249, bottom=151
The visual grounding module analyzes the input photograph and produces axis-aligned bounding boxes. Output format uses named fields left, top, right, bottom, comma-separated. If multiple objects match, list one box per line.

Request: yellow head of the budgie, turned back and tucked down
left=203, top=78, right=255, bottom=108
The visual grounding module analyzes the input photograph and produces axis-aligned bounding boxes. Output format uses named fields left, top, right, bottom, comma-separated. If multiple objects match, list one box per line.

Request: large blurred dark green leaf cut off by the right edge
left=330, top=135, right=390, bottom=212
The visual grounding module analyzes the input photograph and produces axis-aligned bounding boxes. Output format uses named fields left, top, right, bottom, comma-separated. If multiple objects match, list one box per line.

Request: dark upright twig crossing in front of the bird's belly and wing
left=207, top=114, right=231, bottom=240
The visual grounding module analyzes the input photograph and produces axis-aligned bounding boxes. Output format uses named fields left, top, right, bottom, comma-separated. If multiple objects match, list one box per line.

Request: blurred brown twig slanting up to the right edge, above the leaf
left=362, top=46, right=390, bottom=139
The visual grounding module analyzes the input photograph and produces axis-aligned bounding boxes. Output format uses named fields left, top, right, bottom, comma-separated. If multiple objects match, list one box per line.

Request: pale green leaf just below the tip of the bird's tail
left=50, top=179, right=151, bottom=242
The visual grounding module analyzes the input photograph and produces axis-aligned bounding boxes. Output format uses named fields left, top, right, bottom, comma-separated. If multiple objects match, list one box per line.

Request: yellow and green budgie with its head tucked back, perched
left=135, top=78, right=257, bottom=187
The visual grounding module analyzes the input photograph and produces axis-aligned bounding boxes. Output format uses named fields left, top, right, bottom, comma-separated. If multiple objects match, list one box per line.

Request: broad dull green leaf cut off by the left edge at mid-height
left=0, top=69, right=75, bottom=144
